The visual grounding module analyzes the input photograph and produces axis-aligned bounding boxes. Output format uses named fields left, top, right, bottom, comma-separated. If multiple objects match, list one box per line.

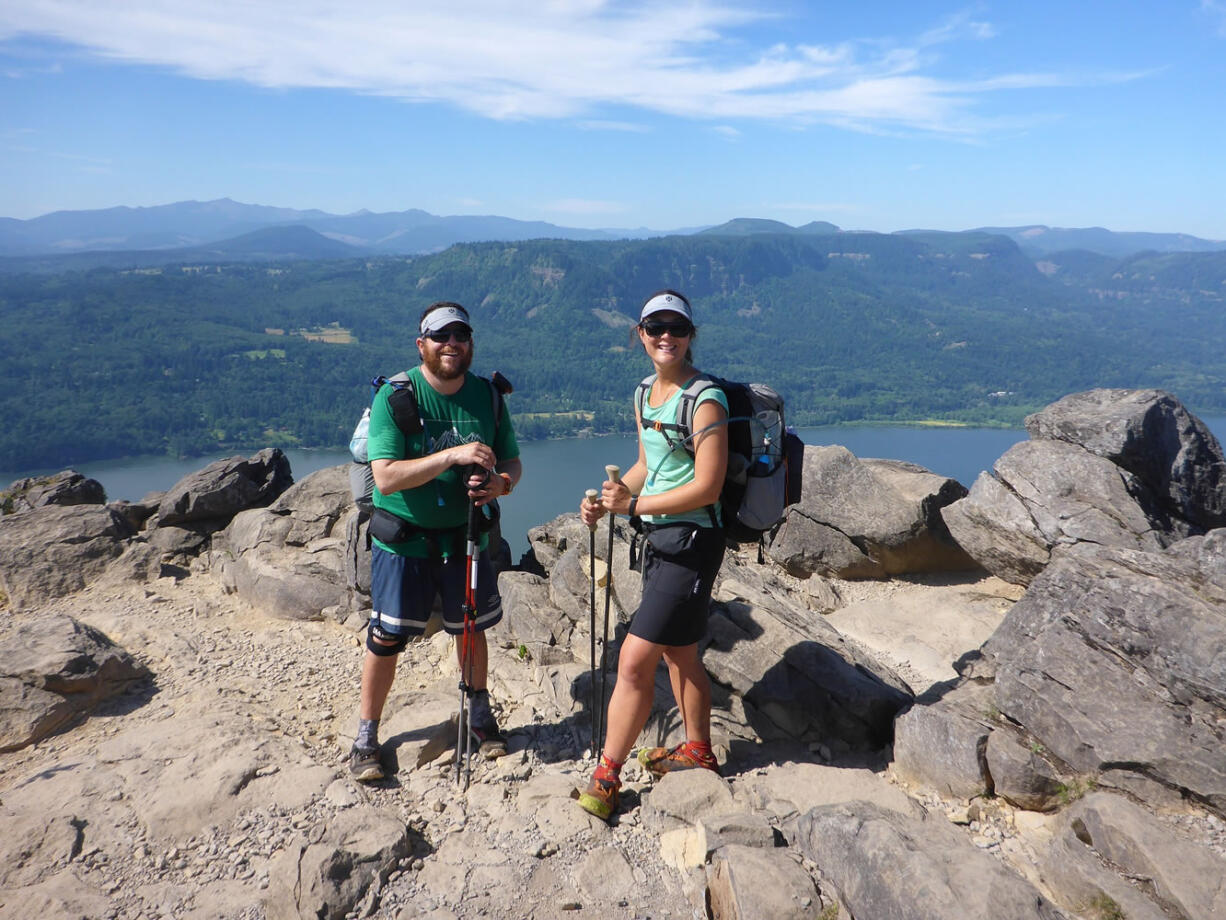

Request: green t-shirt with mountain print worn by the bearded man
left=367, top=367, right=520, bottom=558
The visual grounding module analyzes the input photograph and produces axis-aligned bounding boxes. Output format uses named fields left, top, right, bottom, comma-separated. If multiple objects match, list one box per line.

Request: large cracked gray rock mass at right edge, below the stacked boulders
left=895, top=529, right=1226, bottom=815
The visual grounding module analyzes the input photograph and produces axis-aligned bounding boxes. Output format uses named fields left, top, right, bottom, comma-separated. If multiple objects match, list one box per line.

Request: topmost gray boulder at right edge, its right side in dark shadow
left=1026, top=389, right=1226, bottom=530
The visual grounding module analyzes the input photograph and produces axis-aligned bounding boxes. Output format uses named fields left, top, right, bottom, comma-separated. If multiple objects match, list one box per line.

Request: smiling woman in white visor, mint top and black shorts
left=579, top=291, right=728, bottom=821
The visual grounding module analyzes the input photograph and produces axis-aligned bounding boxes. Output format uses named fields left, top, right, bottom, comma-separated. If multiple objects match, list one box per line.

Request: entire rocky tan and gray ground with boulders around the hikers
left=0, top=390, right=1226, bottom=920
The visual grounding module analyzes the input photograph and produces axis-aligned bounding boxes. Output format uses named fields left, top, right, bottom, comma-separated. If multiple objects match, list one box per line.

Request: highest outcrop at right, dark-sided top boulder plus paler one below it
left=942, top=390, right=1226, bottom=585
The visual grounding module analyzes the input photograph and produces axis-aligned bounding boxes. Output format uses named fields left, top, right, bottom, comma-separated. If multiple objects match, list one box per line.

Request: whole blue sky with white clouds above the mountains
left=0, top=0, right=1226, bottom=239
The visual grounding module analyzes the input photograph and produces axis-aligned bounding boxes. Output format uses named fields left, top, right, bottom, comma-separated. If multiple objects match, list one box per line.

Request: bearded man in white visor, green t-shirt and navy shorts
left=349, top=301, right=522, bottom=781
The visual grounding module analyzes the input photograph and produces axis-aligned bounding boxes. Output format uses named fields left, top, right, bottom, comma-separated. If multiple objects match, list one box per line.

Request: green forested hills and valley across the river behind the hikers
left=0, top=233, right=1226, bottom=470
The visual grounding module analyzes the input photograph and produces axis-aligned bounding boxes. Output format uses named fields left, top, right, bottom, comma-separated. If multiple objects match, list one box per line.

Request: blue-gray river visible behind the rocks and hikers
left=0, top=416, right=1226, bottom=559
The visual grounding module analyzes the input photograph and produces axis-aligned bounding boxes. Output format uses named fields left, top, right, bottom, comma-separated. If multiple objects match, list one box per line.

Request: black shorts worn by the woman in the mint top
left=630, top=523, right=725, bottom=645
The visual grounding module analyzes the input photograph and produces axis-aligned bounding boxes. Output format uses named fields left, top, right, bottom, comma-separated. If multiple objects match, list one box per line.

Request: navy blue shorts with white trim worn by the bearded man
left=370, top=546, right=503, bottom=638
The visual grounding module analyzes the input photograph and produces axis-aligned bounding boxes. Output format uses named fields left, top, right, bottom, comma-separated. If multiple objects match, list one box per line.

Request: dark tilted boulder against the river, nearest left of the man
left=158, top=448, right=293, bottom=526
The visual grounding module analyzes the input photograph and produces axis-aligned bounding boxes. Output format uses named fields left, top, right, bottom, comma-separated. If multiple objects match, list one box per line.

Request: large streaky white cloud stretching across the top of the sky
left=0, top=0, right=1127, bottom=135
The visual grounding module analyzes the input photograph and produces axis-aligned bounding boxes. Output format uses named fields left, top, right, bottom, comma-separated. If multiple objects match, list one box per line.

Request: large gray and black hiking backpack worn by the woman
left=635, top=374, right=804, bottom=547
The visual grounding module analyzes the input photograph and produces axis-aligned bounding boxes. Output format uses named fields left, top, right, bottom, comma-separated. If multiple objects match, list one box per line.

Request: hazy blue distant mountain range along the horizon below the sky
left=0, top=199, right=1226, bottom=264
